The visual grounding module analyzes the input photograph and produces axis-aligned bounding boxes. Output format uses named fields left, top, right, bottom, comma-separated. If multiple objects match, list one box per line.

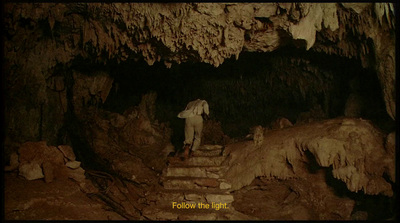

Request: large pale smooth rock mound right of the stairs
left=225, top=118, right=395, bottom=196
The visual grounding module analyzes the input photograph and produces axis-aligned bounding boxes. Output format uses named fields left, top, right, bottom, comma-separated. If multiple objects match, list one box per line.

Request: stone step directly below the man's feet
left=168, top=156, right=226, bottom=166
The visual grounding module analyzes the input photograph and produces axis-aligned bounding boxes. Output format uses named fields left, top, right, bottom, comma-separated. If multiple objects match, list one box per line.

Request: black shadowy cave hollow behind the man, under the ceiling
left=97, top=47, right=392, bottom=150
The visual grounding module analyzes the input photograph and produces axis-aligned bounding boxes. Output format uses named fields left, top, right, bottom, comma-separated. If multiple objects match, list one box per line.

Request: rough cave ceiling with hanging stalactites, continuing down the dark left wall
left=4, top=2, right=395, bottom=158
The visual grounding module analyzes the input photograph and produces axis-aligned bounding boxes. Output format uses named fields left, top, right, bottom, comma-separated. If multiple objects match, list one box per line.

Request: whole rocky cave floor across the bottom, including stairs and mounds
left=4, top=116, right=395, bottom=220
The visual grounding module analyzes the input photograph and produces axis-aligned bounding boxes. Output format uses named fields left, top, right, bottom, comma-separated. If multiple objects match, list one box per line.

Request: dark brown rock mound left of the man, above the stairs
left=81, top=92, right=173, bottom=178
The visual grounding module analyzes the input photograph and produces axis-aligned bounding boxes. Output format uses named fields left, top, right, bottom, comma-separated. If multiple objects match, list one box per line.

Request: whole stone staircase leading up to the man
left=142, top=145, right=254, bottom=220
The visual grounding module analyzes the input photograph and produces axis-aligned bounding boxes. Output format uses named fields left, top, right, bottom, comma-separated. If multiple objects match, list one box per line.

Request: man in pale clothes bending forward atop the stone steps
left=178, top=99, right=210, bottom=159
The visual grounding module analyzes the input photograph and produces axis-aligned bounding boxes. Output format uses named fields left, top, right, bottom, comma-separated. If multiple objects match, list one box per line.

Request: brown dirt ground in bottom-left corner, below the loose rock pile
left=4, top=172, right=126, bottom=220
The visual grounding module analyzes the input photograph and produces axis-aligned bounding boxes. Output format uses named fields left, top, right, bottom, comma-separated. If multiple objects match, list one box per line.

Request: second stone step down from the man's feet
left=164, top=166, right=226, bottom=178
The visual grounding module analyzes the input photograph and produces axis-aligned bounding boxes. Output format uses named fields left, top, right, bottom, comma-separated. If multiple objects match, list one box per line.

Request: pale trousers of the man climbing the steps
left=184, top=115, right=203, bottom=151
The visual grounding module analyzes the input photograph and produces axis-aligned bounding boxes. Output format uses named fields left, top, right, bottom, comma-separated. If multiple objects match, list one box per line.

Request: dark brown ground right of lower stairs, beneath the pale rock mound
left=233, top=169, right=355, bottom=221
